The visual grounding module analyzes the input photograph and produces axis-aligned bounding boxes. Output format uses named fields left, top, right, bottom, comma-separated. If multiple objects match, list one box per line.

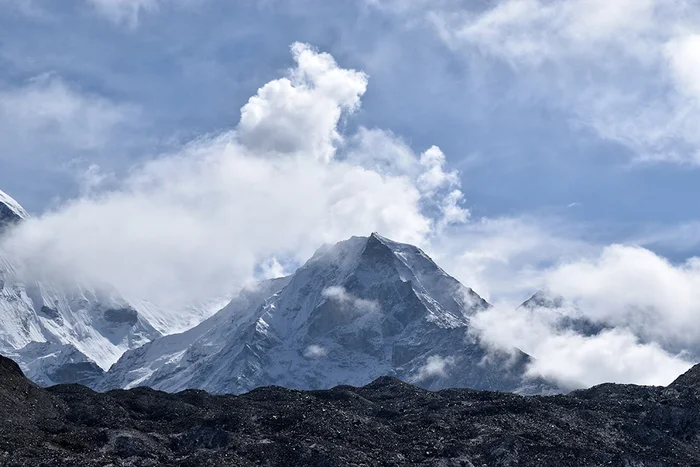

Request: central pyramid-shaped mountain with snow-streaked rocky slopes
left=100, top=234, right=528, bottom=393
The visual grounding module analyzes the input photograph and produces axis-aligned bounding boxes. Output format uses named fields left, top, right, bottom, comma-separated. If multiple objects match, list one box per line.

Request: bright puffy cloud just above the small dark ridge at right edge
left=546, top=245, right=700, bottom=352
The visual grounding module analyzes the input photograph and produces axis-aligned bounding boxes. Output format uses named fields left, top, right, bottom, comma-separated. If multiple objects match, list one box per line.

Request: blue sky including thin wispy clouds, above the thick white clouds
left=0, top=0, right=700, bottom=288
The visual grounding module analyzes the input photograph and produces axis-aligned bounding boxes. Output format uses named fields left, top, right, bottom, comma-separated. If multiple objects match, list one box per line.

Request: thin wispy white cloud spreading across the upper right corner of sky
left=378, top=0, right=700, bottom=165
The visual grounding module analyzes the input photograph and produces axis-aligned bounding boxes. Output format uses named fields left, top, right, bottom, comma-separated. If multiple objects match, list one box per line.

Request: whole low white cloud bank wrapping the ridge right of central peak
left=462, top=241, right=700, bottom=389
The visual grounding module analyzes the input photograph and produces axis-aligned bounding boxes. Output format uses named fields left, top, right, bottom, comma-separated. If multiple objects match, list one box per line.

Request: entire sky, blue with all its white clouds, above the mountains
left=0, top=0, right=700, bottom=392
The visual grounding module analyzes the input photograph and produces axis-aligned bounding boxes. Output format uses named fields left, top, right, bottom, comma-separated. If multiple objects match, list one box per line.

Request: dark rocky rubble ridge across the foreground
left=0, top=357, right=700, bottom=467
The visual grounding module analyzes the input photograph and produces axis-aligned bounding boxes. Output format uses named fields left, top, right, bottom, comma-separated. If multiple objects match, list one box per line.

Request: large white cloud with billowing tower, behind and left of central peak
left=4, top=44, right=468, bottom=322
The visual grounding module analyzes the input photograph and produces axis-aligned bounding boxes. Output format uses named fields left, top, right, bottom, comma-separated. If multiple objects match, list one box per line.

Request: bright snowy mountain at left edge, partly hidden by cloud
left=0, top=188, right=161, bottom=385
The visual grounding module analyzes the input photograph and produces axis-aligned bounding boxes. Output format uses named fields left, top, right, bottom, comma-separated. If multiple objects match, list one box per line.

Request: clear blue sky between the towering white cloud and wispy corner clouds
left=5, top=0, right=700, bottom=250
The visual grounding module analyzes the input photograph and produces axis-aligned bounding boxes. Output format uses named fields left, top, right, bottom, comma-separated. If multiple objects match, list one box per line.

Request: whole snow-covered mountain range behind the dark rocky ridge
left=0, top=186, right=543, bottom=393
